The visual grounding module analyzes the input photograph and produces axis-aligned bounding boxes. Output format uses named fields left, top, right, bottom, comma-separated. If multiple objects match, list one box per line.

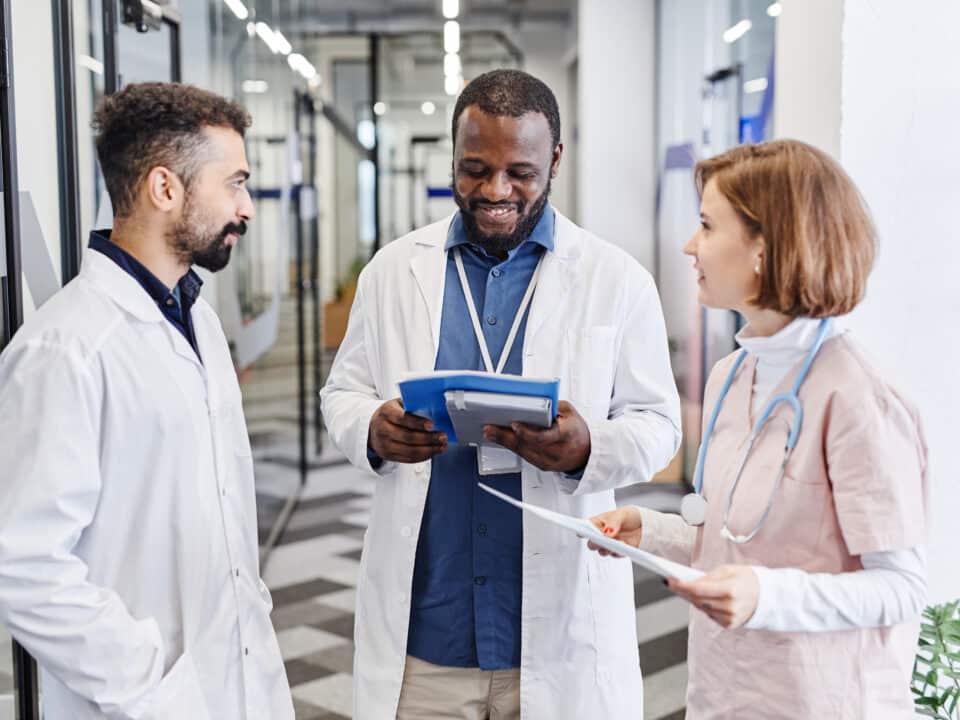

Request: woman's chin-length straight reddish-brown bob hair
left=694, top=140, right=876, bottom=318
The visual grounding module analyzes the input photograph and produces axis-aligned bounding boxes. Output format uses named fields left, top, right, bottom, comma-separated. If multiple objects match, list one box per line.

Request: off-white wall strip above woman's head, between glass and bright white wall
left=774, top=0, right=840, bottom=158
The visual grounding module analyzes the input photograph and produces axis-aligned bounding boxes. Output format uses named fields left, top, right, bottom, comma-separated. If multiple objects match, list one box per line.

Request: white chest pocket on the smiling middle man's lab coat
left=567, top=325, right=617, bottom=420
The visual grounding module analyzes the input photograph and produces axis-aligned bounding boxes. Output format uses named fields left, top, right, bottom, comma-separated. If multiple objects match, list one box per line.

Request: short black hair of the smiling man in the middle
left=451, top=69, right=560, bottom=147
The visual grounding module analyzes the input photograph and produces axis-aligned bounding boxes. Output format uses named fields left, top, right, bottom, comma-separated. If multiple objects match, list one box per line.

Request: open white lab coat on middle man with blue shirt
left=322, top=213, right=680, bottom=720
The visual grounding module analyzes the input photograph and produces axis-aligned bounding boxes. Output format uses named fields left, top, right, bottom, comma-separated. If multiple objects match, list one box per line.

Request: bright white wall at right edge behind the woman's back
left=840, top=0, right=960, bottom=602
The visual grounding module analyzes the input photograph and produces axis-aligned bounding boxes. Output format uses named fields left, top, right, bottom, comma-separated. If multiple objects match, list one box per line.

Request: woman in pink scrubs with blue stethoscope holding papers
left=593, top=141, right=926, bottom=720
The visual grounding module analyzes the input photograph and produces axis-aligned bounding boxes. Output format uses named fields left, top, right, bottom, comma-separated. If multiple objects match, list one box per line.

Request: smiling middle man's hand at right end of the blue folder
left=483, top=400, right=590, bottom=473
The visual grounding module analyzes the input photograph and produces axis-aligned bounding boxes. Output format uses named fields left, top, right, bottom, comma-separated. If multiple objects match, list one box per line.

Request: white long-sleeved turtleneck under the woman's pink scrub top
left=640, top=318, right=927, bottom=632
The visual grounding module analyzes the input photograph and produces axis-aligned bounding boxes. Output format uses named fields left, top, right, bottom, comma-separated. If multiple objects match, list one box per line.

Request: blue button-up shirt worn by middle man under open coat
left=407, top=206, right=554, bottom=670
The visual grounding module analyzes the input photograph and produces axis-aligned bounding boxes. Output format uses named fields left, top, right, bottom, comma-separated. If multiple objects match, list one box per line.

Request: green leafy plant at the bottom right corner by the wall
left=910, top=600, right=960, bottom=720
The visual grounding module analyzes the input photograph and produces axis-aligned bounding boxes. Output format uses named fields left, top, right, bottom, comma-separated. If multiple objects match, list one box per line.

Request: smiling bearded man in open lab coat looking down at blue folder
left=322, top=70, right=680, bottom=720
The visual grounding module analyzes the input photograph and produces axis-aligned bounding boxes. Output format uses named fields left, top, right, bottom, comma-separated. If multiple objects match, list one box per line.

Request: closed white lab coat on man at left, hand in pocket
left=0, top=251, right=293, bottom=720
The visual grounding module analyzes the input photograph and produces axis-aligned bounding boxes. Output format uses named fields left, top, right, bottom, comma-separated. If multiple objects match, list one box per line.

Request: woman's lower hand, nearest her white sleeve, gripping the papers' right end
left=667, top=565, right=760, bottom=628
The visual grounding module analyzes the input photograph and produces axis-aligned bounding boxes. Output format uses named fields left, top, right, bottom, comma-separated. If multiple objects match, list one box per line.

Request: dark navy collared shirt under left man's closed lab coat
left=90, top=230, right=203, bottom=358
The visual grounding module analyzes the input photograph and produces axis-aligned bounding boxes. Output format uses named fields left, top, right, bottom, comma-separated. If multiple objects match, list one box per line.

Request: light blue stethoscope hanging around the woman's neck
left=680, top=318, right=832, bottom=545
